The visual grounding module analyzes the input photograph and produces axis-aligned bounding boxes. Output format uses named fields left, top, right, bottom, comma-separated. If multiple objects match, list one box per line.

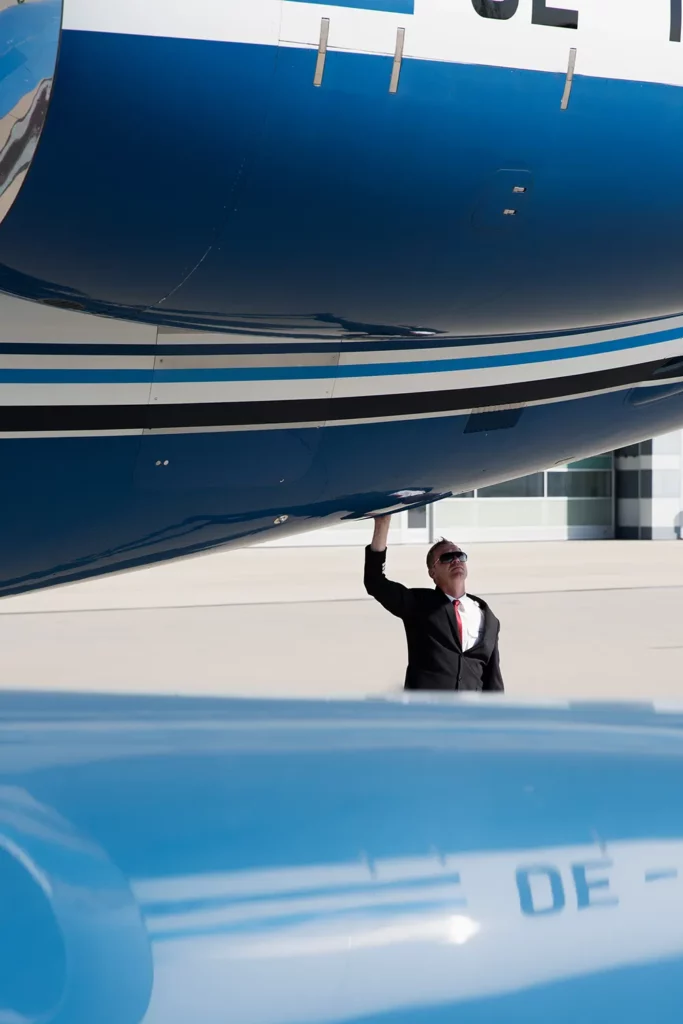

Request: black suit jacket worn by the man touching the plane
left=365, top=548, right=504, bottom=692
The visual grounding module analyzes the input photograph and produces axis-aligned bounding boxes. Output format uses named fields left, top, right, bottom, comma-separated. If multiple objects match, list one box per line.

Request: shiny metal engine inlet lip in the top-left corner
left=0, top=0, right=61, bottom=221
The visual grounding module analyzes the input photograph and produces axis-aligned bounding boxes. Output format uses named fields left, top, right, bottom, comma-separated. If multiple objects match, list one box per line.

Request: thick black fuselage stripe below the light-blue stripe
left=0, top=359, right=681, bottom=432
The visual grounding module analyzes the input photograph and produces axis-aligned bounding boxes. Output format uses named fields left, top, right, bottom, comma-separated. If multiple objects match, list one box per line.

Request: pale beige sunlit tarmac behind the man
left=0, top=528, right=683, bottom=703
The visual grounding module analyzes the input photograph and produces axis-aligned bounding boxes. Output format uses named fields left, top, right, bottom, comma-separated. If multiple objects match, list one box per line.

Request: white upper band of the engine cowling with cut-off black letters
left=63, top=0, right=683, bottom=88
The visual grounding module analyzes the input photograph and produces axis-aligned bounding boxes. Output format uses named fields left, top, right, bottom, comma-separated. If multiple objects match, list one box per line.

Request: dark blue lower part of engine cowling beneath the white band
left=0, top=32, right=683, bottom=337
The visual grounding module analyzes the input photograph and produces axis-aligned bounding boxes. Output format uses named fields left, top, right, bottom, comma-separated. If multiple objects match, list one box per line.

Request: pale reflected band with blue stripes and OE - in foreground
left=133, top=836, right=683, bottom=1024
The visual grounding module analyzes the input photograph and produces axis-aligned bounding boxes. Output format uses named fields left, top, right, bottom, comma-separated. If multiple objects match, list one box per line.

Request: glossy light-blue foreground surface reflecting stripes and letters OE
left=0, top=693, right=683, bottom=1024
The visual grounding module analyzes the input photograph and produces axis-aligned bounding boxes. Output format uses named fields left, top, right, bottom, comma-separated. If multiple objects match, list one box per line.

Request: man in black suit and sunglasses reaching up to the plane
left=365, top=515, right=504, bottom=692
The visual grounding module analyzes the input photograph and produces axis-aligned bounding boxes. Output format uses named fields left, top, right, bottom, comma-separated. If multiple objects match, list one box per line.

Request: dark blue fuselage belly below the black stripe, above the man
left=0, top=380, right=683, bottom=596
